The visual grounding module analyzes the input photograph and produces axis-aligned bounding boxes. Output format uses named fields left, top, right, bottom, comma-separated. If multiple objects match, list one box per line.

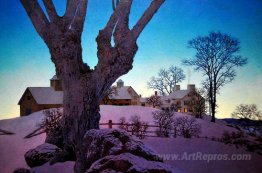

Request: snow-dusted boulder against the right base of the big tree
left=84, top=129, right=161, bottom=167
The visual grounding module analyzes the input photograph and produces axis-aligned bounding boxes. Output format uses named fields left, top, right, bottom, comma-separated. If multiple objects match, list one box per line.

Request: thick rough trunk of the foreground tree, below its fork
left=63, top=79, right=100, bottom=173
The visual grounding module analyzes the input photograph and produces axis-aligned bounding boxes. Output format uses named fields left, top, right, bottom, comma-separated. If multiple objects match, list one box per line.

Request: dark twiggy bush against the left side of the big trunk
left=39, top=109, right=63, bottom=148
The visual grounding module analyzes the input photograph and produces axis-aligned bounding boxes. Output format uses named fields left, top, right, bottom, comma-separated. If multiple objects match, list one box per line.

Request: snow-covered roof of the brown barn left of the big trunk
left=19, top=87, right=63, bottom=105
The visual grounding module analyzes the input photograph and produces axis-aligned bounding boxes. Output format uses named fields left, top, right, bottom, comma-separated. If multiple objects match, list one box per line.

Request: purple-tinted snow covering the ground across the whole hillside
left=0, top=106, right=262, bottom=173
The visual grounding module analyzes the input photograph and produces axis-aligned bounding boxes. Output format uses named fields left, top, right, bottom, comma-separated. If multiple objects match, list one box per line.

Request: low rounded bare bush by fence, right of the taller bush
left=174, top=116, right=201, bottom=138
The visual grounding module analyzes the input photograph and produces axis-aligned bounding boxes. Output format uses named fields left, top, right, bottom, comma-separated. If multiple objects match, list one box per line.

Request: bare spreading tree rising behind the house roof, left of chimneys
left=147, top=65, right=186, bottom=95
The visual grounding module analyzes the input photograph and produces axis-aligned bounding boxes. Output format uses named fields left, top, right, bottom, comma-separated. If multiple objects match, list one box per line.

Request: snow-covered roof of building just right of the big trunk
left=109, top=86, right=138, bottom=100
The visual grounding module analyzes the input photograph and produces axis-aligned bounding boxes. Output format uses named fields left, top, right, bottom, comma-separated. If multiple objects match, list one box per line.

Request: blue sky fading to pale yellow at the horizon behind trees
left=0, top=0, right=262, bottom=119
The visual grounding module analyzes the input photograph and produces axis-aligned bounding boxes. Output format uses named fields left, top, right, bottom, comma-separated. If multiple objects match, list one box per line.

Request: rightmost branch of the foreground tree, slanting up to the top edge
left=132, top=0, right=165, bottom=39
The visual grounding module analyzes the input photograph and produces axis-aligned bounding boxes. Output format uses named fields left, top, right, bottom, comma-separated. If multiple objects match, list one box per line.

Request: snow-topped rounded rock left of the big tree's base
left=24, top=143, right=62, bottom=167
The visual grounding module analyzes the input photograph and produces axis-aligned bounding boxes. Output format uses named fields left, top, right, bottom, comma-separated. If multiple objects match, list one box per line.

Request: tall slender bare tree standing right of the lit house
left=183, top=32, right=247, bottom=122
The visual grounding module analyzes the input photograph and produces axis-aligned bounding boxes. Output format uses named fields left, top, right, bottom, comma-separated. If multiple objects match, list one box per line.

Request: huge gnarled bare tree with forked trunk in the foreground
left=21, top=0, right=164, bottom=173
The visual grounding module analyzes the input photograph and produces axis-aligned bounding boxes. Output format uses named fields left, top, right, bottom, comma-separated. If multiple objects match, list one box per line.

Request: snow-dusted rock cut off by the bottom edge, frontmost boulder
left=86, top=153, right=172, bottom=173
